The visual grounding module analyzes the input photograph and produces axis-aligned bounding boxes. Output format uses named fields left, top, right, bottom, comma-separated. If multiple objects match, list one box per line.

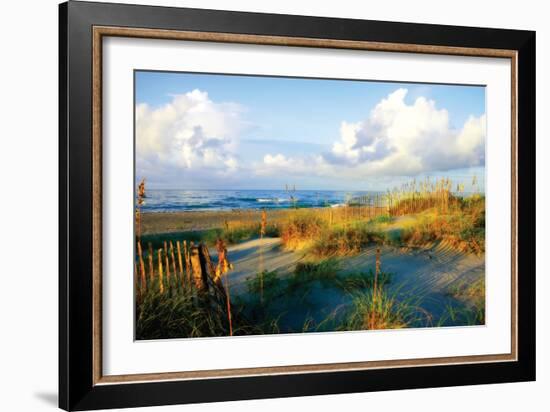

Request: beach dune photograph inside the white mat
left=132, top=70, right=486, bottom=340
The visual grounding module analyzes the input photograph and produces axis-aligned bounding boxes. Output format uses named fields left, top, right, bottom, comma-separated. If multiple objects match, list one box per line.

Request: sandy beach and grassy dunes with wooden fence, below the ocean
left=135, top=179, right=485, bottom=339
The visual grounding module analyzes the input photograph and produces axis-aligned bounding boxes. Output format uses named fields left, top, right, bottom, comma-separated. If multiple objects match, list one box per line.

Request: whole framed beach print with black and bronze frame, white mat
left=59, top=1, right=535, bottom=410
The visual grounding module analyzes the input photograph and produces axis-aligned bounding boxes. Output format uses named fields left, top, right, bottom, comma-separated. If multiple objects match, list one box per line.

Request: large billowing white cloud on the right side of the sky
left=323, top=88, right=486, bottom=175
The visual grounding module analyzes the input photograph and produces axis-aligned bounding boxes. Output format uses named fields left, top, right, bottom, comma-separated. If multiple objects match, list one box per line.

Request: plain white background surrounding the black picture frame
left=0, top=0, right=550, bottom=412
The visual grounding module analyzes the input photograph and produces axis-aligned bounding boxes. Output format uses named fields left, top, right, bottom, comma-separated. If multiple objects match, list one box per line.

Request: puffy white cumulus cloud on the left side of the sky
left=136, top=90, right=244, bottom=179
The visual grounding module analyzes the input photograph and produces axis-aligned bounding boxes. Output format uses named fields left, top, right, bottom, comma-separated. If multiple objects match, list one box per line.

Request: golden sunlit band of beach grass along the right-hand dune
left=281, top=196, right=485, bottom=257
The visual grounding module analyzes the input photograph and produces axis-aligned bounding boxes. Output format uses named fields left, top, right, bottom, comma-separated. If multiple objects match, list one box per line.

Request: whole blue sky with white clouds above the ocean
left=135, top=71, right=485, bottom=190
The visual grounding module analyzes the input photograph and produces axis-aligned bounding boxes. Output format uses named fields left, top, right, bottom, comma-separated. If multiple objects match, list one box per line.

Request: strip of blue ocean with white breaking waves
left=142, top=189, right=382, bottom=212
